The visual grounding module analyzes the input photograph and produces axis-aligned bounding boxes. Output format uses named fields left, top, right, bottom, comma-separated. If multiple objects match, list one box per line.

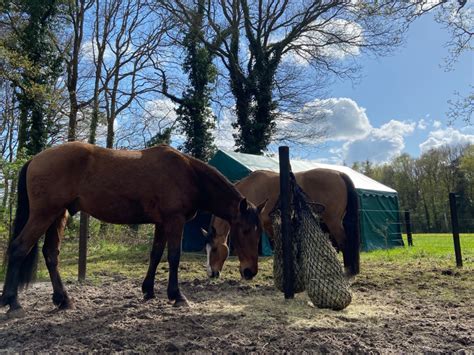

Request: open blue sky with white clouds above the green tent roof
left=126, top=9, right=474, bottom=165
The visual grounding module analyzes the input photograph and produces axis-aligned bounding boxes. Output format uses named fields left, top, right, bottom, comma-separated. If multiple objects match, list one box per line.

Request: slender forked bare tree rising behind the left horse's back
left=91, top=0, right=167, bottom=148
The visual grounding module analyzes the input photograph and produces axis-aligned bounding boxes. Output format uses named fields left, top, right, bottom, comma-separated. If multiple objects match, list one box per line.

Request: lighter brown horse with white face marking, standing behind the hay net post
left=206, top=169, right=360, bottom=277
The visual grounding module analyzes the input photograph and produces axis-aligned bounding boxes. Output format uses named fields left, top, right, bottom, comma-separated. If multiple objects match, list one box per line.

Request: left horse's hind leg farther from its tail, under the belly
left=43, top=211, right=73, bottom=309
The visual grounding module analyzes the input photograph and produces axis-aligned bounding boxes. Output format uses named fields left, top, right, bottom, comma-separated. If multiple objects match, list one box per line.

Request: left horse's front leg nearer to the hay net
left=165, top=217, right=189, bottom=307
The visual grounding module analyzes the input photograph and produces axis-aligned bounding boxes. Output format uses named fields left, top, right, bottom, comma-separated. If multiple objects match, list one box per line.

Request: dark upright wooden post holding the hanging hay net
left=278, top=146, right=295, bottom=299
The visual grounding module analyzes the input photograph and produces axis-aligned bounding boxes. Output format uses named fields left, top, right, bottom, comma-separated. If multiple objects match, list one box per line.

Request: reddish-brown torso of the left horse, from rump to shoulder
left=28, top=142, right=197, bottom=223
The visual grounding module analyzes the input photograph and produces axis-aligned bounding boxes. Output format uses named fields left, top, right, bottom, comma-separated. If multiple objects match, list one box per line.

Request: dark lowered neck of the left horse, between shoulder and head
left=194, top=160, right=243, bottom=222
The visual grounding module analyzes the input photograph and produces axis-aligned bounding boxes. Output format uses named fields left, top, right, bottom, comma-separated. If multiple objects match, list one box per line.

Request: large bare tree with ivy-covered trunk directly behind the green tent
left=163, top=0, right=422, bottom=154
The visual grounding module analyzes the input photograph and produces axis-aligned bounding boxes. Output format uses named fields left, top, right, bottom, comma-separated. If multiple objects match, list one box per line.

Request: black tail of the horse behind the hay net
left=341, top=174, right=360, bottom=276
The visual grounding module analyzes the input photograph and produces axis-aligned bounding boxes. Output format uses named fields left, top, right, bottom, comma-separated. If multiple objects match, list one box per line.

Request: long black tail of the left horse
left=5, top=161, right=38, bottom=288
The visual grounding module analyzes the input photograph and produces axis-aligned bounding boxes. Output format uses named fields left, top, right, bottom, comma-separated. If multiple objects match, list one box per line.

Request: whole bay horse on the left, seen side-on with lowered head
left=0, top=142, right=261, bottom=312
